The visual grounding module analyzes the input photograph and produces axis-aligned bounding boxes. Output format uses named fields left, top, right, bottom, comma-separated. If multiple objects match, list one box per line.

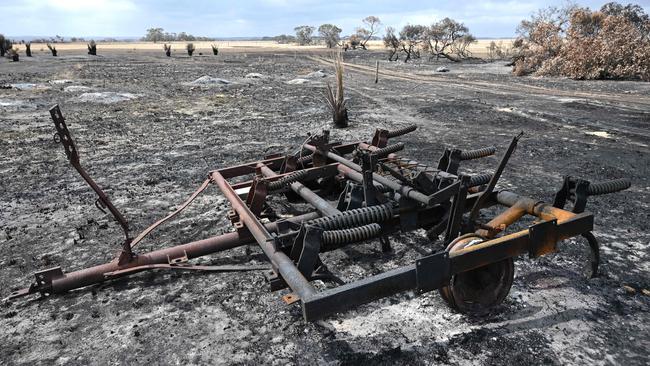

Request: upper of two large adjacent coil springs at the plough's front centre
left=307, top=204, right=393, bottom=230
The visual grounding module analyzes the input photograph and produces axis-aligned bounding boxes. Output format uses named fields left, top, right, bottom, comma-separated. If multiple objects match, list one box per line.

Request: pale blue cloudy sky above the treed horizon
left=0, top=0, right=650, bottom=37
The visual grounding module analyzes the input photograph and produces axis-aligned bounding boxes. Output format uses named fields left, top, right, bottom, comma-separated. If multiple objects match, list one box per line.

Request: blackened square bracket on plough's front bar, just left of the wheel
left=415, top=251, right=451, bottom=294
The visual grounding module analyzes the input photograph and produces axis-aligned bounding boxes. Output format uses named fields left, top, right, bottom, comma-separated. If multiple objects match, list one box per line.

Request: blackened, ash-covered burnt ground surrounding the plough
left=0, top=48, right=650, bottom=365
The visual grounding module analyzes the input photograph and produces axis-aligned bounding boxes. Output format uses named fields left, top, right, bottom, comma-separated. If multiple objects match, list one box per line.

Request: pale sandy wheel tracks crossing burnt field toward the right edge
left=307, top=56, right=650, bottom=138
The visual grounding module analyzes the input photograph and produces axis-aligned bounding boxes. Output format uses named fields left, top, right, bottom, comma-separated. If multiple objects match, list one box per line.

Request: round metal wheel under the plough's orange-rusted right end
left=440, top=235, right=515, bottom=315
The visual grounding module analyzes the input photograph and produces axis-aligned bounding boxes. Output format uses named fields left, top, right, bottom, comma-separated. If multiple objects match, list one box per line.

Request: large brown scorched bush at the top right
left=513, top=3, right=650, bottom=80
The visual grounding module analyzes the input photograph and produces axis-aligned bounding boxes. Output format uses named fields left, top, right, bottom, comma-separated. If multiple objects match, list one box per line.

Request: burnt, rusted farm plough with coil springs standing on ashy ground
left=7, top=106, right=630, bottom=321
